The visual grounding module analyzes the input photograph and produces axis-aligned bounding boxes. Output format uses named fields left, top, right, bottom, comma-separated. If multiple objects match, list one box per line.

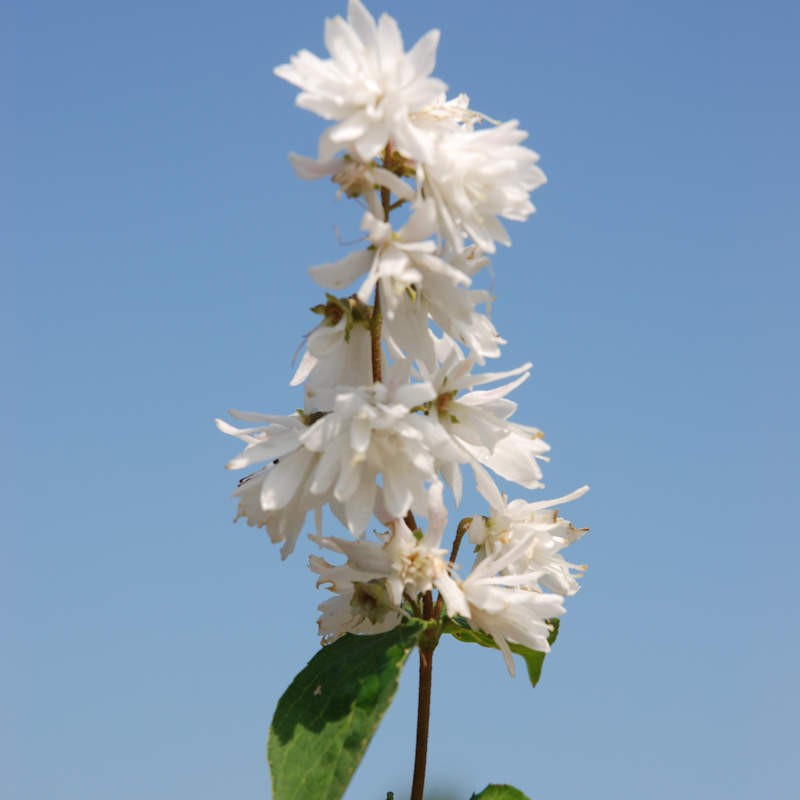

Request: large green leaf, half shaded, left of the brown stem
left=267, top=625, right=424, bottom=800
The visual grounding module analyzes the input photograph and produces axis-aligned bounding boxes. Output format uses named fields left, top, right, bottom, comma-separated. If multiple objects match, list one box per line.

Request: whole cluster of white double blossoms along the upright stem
left=217, top=0, right=586, bottom=674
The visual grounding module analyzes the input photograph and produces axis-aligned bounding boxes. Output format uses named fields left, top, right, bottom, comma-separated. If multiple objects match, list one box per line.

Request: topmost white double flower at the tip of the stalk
left=275, top=0, right=447, bottom=161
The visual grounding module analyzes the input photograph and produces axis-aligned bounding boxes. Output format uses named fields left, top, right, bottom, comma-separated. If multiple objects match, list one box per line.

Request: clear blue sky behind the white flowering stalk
left=6, top=0, right=800, bottom=800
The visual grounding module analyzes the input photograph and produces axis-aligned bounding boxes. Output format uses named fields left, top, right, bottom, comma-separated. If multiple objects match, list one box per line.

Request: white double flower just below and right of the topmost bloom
left=420, top=120, right=547, bottom=253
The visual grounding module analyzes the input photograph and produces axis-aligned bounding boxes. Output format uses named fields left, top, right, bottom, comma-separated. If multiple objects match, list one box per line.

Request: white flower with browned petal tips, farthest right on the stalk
left=469, top=486, right=589, bottom=595
